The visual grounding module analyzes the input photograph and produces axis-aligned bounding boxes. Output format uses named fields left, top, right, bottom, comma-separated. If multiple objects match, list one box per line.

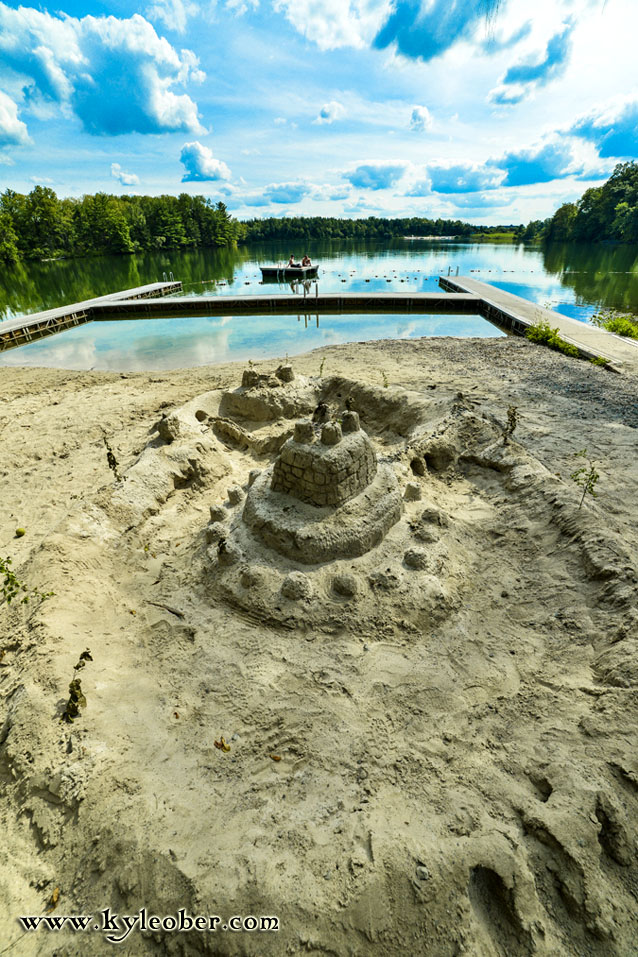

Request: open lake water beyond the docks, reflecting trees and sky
left=0, top=239, right=638, bottom=318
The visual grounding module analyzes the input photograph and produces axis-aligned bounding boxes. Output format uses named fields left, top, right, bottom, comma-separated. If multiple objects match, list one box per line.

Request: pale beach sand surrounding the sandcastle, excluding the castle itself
left=0, top=330, right=638, bottom=957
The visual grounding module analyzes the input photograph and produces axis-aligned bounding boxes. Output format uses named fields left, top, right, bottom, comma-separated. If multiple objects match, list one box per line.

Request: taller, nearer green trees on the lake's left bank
left=0, top=186, right=242, bottom=263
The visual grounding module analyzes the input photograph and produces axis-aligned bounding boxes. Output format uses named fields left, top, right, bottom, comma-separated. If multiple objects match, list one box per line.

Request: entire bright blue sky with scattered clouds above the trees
left=0, top=0, right=638, bottom=225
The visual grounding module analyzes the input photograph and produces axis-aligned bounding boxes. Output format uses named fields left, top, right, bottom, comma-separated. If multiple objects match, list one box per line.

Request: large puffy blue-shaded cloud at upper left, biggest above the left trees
left=0, top=2, right=204, bottom=135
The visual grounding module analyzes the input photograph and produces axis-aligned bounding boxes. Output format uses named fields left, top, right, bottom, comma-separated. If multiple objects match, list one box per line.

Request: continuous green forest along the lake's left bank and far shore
left=0, top=186, right=516, bottom=263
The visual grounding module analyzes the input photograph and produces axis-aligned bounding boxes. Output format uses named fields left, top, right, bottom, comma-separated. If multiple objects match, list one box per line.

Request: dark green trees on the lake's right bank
left=516, top=160, right=638, bottom=243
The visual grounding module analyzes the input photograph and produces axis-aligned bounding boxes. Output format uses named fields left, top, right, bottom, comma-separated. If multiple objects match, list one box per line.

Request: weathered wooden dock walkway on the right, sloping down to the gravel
left=439, top=276, right=638, bottom=371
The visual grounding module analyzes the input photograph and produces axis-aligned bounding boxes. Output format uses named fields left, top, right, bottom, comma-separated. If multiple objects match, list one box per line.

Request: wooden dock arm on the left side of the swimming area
left=0, top=282, right=182, bottom=352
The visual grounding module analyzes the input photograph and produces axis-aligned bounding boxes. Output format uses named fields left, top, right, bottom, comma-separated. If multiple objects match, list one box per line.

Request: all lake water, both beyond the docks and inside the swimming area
left=0, top=240, right=638, bottom=371
